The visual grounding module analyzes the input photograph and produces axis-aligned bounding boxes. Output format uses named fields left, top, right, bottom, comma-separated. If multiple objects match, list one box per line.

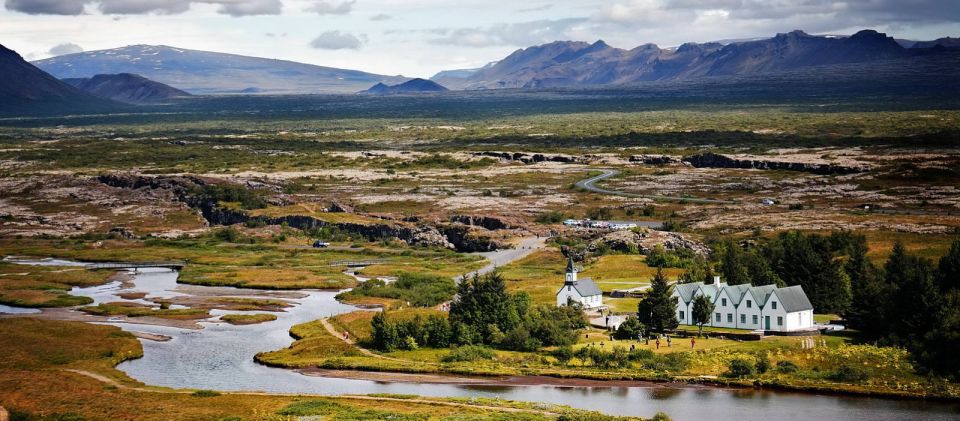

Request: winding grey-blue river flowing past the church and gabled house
left=1, top=260, right=960, bottom=421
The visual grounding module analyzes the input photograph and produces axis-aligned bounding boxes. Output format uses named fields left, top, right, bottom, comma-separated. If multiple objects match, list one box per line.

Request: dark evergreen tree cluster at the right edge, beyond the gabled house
left=844, top=240, right=960, bottom=379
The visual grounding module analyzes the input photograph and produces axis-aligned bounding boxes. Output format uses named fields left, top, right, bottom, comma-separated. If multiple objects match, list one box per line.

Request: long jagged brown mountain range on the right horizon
left=448, top=30, right=940, bottom=89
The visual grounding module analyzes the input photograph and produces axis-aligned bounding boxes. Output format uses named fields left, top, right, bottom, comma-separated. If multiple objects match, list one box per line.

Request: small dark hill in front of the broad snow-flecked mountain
left=63, top=73, right=190, bottom=104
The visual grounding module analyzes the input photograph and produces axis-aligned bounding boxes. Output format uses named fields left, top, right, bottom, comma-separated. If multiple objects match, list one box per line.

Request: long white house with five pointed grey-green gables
left=672, top=276, right=813, bottom=332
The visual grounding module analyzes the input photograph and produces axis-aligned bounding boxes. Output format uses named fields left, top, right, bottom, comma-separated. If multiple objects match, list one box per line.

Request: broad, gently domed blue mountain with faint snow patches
left=34, top=45, right=408, bottom=94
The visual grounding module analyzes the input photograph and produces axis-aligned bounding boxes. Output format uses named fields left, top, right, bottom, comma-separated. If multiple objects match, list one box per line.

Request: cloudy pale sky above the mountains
left=0, top=0, right=960, bottom=77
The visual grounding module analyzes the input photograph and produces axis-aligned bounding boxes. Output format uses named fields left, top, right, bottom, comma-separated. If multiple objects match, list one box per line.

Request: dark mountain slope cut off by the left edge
left=0, top=45, right=119, bottom=115
